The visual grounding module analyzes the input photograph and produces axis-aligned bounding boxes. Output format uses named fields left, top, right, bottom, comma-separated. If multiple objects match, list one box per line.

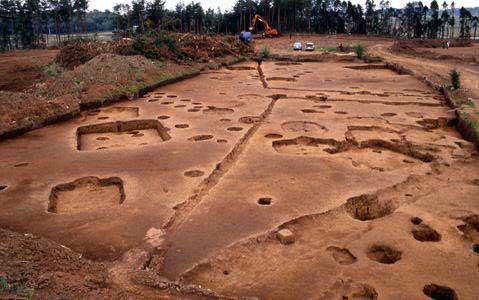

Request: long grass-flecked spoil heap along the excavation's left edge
left=0, top=54, right=188, bottom=138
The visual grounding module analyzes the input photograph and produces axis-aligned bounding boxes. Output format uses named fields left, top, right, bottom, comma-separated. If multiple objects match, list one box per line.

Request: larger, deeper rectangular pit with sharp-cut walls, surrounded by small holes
left=77, top=120, right=171, bottom=151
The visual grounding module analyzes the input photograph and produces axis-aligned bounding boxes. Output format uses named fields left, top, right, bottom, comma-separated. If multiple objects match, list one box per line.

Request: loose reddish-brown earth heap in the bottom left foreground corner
left=0, top=229, right=129, bottom=299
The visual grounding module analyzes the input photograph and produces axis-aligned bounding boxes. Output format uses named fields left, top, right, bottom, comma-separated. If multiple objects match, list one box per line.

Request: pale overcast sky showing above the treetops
left=90, top=0, right=479, bottom=10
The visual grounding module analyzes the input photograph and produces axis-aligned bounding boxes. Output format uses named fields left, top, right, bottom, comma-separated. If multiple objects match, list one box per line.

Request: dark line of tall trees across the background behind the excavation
left=0, top=0, right=479, bottom=49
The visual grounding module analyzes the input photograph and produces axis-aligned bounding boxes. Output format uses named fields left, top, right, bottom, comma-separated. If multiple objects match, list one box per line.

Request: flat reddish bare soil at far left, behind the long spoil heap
left=0, top=50, right=58, bottom=92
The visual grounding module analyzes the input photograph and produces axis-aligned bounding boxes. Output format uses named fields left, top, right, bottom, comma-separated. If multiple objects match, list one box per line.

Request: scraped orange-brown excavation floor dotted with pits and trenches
left=0, top=54, right=479, bottom=300
